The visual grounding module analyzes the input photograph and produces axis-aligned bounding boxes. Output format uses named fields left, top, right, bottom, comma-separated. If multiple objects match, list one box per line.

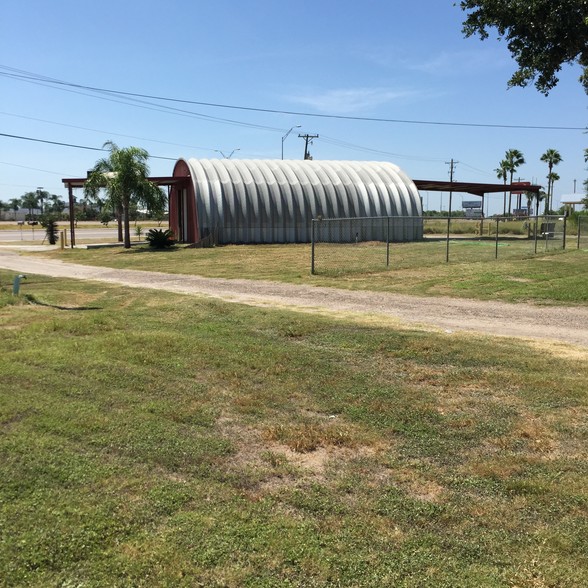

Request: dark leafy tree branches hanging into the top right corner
left=460, top=0, right=588, bottom=95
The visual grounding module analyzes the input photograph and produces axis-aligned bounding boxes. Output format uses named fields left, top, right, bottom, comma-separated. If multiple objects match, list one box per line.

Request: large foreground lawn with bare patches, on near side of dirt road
left=0, top=274, right=588, bottom=588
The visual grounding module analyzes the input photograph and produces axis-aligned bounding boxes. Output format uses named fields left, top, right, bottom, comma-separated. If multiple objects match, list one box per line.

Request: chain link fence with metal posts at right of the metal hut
left=311, top=216, right=576, bottom=274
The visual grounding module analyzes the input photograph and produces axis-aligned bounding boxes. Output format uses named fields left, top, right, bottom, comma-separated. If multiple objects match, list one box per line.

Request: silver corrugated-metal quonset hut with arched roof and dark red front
left=169, top=159, right=423, bottom=244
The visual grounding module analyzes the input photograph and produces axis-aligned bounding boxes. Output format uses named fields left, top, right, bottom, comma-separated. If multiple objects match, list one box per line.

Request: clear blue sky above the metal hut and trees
left=0, top=0, right=588, bottom=214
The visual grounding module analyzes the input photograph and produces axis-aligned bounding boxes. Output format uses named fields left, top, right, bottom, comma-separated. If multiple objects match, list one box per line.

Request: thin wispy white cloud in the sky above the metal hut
left=289, top=88, right=412, bottom=115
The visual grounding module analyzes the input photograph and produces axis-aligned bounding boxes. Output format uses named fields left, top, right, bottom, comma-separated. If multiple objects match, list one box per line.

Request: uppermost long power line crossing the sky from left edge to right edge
left=0, top=65, right=586, bottom=131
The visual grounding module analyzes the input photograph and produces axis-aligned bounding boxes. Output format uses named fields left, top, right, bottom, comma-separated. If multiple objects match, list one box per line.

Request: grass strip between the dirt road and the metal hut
left=33, top=241, right=588, bottom=305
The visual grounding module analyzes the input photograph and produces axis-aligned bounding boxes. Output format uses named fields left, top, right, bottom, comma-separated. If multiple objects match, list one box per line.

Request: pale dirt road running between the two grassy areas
left=0, top=250, right=588, bottom=348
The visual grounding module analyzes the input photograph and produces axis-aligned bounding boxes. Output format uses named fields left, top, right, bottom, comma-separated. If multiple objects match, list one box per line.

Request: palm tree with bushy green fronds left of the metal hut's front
left=84, top=141, right=165, bottom=249
